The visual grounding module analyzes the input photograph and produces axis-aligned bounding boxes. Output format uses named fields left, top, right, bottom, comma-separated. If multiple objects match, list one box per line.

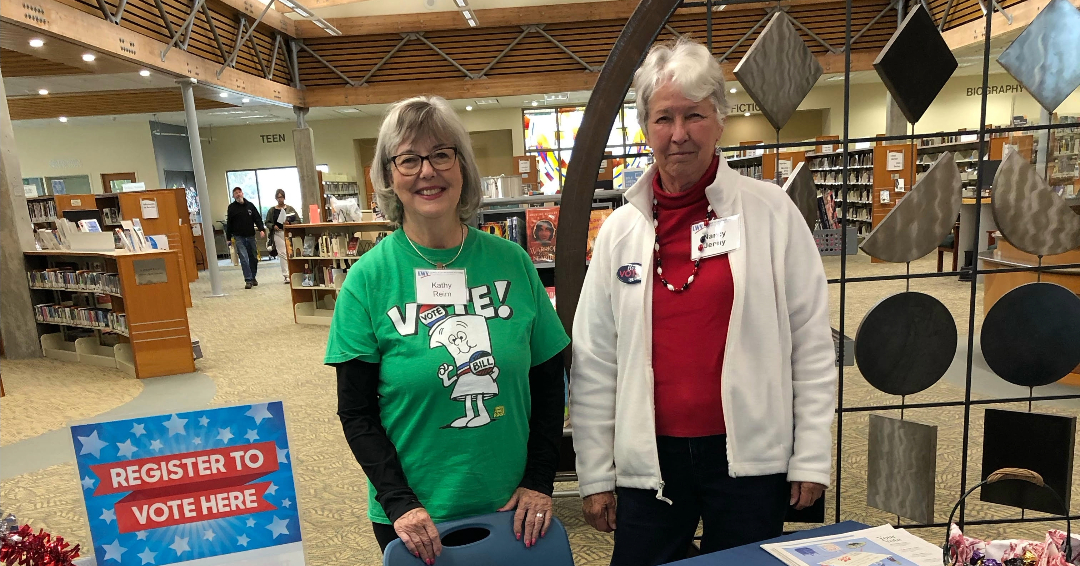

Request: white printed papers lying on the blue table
left=761, top=525, right=942, bottom=566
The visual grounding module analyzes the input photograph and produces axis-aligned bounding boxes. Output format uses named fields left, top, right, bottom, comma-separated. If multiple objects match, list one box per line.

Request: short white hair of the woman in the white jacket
left=634, top=38, right=730, bottom=133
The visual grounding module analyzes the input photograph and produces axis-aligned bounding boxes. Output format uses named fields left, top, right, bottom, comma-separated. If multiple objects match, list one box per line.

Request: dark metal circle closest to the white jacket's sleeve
left=855, top=292, right=957, bottom=395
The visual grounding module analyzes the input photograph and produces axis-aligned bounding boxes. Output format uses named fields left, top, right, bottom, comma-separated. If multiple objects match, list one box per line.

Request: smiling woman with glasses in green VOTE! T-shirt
left=325, top=97, right=569, bottom=564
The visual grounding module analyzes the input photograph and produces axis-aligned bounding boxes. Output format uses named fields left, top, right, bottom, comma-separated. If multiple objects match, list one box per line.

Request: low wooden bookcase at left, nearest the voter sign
left=25, top=250, right=194, bottom=379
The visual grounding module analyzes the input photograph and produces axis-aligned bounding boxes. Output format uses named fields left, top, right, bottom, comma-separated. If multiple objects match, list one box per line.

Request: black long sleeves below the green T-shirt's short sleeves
left=337, top=352, right=565, bottom=523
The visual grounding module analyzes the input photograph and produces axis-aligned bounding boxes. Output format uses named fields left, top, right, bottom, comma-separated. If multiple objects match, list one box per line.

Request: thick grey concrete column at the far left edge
left=0, top=66, right=41, bottom=360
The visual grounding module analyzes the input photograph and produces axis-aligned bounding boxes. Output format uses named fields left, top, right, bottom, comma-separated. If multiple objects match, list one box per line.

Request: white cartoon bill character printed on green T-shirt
left=419, top=305, right=499, bottom=429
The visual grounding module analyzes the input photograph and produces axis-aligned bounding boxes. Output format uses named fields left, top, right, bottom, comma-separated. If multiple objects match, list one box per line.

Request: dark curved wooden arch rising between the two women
left=555, top=0, right=681, bottom=334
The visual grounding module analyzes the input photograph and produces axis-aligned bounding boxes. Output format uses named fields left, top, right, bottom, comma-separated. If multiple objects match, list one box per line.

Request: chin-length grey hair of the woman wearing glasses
left=372, top=96, right=483, bottom=225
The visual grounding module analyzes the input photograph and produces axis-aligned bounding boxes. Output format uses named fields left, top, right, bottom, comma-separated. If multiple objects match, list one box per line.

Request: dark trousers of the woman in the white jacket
left=611, top=434, right=791, bottom=566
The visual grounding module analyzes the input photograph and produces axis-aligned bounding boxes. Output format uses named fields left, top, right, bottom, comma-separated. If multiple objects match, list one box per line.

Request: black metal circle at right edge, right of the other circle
left=981, top=283, right=1080, bottom=387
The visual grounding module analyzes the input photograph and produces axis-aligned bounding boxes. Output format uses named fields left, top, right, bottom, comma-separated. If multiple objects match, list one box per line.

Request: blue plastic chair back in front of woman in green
left=382, top=511, right=573, bottom=566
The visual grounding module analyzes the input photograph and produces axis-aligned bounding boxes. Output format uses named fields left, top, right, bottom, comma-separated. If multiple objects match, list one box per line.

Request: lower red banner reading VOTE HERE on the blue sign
left=114, top=482, right=278, bottom=533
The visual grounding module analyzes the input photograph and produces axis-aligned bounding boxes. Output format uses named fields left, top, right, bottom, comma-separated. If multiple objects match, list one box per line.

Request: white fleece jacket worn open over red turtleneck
left=570, top=157, right=837, bottom=499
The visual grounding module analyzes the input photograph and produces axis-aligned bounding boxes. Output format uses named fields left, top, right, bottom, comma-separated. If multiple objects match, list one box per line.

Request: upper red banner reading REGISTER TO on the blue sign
left=90, top=442, right=278, bottom=499
